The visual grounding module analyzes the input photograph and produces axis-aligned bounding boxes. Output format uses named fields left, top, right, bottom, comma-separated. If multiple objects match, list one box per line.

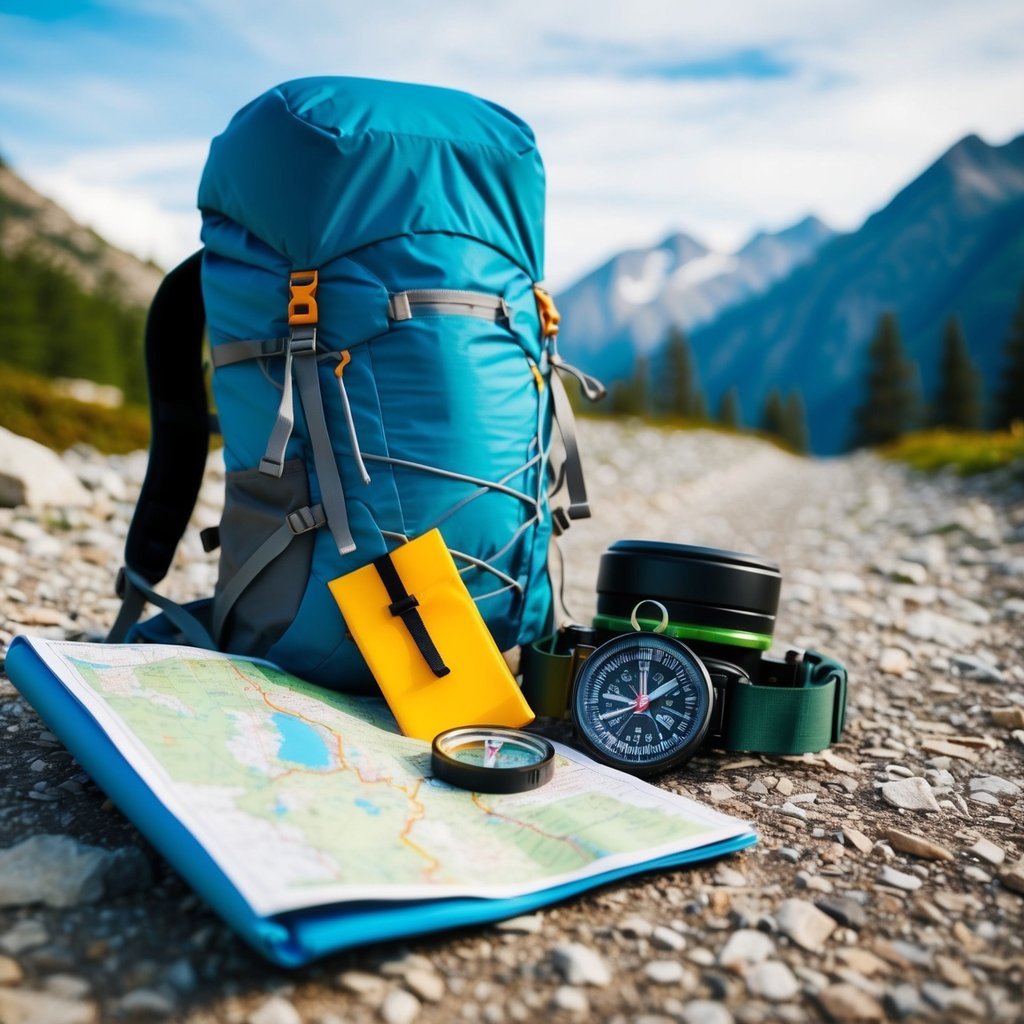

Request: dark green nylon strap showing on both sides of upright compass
left=522, top=637, right=847, bottom=754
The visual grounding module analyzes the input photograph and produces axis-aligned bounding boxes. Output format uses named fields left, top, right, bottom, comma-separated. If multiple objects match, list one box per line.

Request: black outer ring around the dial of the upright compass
left=569, top=632, right=715, bottom=775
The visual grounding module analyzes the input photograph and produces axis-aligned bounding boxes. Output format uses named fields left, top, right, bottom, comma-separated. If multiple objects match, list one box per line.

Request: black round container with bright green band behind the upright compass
left=594, top=541, right=782, bottom=674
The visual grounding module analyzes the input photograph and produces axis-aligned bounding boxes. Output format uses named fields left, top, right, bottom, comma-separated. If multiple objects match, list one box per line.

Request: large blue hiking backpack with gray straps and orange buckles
left=108, top=78, right=600, bottom=690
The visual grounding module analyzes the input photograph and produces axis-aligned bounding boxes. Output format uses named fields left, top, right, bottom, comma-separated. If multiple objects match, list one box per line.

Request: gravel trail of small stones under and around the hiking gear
left=0, top=421, right=1024, bottom=1024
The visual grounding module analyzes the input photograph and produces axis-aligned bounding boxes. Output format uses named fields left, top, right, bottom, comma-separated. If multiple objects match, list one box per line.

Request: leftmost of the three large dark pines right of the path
left=854, top=312, right=918, bottom=445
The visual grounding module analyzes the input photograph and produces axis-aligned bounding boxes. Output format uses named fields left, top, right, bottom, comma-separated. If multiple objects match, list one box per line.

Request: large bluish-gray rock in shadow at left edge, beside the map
left=0, top=835, right=152, bottom=907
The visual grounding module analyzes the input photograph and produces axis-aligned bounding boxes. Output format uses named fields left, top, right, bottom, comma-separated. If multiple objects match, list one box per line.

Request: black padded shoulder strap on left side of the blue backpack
left=106, top=250, right=213, bottom=646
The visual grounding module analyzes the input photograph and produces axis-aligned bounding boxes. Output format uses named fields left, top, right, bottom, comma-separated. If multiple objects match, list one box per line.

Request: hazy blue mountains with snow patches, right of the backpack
left=557, top=135, right=1024, bottom=454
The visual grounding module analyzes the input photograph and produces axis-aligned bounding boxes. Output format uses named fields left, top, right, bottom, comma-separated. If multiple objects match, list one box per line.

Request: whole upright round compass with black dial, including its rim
left=571, top=633, right=712, bottom=775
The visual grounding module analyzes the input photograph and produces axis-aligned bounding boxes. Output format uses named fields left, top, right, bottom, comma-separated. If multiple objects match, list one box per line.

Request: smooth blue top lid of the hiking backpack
left=199, top=77, right=544, bottom=281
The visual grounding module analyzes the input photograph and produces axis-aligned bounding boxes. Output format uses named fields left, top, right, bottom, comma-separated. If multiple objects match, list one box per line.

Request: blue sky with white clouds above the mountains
left=0, top=0, right=1024, bottom=290
